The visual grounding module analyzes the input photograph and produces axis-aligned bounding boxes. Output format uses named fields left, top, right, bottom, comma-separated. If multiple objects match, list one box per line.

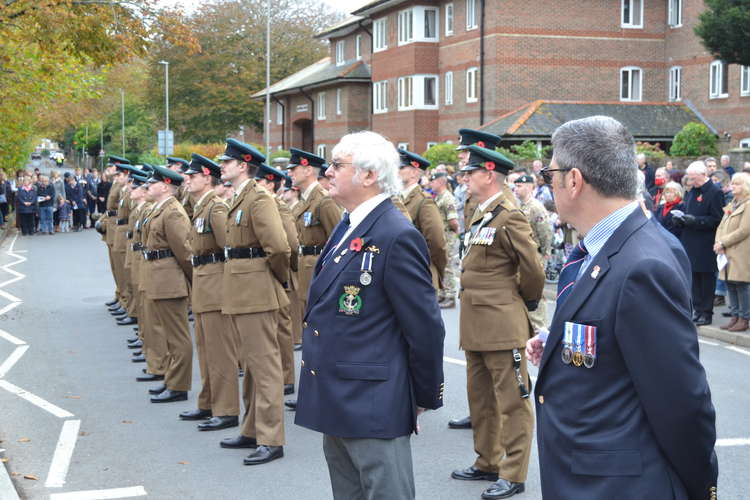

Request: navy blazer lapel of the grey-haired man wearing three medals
left=539, top=208, right=648, bottom=374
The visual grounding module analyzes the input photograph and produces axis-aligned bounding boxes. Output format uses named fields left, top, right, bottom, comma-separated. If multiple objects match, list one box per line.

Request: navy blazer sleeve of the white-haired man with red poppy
left=384, top=230, right=445, bottom=410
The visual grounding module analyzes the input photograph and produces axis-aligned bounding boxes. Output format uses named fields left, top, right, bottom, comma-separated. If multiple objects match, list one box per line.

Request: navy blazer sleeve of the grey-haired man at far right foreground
left=615, top=259, right=718, bottom=499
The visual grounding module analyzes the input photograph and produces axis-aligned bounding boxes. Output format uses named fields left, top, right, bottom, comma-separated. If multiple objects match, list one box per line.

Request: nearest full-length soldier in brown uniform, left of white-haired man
left=219, top=139, right=291, bottom=465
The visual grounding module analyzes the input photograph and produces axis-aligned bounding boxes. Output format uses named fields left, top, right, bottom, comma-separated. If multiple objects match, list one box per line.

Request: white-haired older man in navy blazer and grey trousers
left=295, top=132, right=445, bottom=500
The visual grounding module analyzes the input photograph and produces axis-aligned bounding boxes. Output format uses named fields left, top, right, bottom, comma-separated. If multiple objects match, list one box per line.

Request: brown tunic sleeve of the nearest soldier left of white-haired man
left=250, top=193, right=291, bottom=283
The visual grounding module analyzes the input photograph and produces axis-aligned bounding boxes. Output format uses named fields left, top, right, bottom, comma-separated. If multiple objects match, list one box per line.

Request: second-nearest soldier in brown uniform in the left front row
left=180, top=153, right=240, bottom=431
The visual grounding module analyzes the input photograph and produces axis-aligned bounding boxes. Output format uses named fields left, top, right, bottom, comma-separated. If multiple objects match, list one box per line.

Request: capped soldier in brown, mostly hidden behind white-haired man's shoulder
left=398, top=149, right=448, bottom=293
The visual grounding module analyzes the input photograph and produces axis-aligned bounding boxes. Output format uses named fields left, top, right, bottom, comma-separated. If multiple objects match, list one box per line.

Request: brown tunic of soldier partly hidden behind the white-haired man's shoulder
left=404, top=186, right=448, bottom=290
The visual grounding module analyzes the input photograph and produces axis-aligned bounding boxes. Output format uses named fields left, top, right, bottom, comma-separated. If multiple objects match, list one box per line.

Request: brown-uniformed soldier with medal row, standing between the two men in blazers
left=451, top=146, right=544, bottom=500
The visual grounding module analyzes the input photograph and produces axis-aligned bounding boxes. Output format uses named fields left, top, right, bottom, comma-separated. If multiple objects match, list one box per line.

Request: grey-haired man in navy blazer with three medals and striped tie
left=526, top=117, right=718, bottom=500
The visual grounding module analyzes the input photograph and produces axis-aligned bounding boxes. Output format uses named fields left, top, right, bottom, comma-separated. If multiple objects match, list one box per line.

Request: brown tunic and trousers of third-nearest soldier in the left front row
left=144, top=196, right=193, bottom=391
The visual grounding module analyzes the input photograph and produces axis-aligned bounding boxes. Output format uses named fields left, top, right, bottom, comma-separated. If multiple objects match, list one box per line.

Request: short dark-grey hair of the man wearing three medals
left=552, top=116, right=638, bottom=200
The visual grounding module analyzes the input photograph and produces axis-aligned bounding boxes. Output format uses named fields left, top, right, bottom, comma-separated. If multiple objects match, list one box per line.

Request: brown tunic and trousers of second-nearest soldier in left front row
left=190, top=191, right=240, bottom=416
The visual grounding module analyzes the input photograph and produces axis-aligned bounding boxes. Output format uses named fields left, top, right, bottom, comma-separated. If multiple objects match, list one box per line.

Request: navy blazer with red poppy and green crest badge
left=295, top=199, right=445, bottom=439
